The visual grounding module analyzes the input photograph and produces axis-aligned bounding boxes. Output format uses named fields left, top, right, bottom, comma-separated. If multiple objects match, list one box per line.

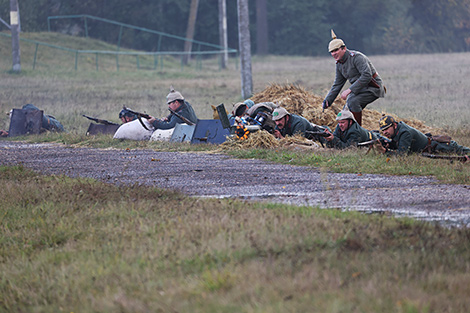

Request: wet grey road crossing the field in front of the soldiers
left=0, top=141, right=470, bottom=227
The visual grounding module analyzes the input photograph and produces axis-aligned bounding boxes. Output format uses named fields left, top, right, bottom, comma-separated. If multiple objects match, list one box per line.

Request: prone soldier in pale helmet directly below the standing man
left=325, top=110, right=377, bottom=149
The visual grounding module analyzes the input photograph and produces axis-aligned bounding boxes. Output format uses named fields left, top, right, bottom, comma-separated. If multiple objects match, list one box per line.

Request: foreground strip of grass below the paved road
left=0, top=167, right=470, bottom=312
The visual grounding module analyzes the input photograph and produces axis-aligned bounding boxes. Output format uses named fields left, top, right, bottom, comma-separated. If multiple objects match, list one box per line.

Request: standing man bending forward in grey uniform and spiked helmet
left=323, top=30, right=385, bottom=125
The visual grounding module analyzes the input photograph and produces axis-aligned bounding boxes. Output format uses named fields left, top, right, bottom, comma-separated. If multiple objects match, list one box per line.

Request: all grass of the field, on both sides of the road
left=0, top=34, right=470, bottom=313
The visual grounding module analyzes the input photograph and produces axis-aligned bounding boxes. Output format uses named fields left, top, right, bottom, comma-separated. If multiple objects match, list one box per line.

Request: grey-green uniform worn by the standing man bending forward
left=325, top=49, right=385, bottom=112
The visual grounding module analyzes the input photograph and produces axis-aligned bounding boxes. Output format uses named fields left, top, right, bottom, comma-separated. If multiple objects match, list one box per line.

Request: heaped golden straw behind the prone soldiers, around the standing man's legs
left=251, top=84, right=442, bottom=133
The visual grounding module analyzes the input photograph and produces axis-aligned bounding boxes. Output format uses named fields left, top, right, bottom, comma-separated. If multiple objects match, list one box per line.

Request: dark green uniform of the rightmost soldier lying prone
left=387, top=122, right=470, bottom=155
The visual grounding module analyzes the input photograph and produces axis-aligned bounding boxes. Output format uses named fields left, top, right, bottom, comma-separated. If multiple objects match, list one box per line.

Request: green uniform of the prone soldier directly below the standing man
left=326, top=120, right=377, bottom=149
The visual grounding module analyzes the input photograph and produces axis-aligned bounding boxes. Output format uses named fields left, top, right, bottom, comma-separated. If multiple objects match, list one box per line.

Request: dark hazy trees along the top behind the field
left=0, top=0, right=470, bottom=55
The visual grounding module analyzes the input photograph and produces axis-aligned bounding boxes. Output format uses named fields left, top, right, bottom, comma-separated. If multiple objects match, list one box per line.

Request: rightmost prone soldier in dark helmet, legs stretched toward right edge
left=377, top=115, right=470, bottom=159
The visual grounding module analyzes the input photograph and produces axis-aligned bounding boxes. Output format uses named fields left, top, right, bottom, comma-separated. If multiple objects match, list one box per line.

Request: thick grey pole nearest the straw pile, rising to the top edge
left=238, top=0, right=253, bottom=99
